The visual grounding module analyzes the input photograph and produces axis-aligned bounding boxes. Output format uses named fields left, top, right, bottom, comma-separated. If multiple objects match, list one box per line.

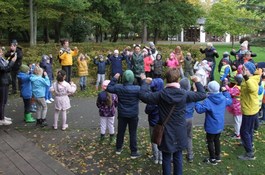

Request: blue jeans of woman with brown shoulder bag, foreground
left=162, top=151, right=183, bottom=175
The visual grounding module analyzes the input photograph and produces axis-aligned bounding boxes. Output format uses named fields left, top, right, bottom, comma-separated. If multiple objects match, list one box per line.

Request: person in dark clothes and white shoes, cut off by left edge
left=0, top=49, right=17, bottom=125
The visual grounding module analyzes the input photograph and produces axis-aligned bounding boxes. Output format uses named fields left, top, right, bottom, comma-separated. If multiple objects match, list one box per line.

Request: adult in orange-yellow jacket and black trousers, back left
left=59, top=40, right=78, bottom=83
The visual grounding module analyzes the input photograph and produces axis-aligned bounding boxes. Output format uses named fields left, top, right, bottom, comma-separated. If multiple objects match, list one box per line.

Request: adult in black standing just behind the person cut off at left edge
left=5, top=43, right=23, bottom=94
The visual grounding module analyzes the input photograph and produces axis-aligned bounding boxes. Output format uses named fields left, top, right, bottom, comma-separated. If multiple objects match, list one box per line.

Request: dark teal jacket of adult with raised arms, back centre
left=123, top=50, right=151, bottom=78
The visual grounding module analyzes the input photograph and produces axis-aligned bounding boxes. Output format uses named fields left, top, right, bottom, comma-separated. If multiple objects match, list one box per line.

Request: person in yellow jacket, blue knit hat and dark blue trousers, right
left=238, top=62, right=260, bottom=160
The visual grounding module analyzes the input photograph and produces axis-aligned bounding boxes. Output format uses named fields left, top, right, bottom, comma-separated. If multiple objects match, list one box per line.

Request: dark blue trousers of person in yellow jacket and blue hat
left=240, top=113, right=258, bottom=152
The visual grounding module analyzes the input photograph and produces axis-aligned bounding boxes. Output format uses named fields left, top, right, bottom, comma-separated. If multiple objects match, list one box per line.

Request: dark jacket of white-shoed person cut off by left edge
left=0, top=60, right=15, bottom=86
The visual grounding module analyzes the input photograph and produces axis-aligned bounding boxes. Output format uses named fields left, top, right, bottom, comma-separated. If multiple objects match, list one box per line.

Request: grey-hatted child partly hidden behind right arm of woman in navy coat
left=179, top=77, right=197, bottom=163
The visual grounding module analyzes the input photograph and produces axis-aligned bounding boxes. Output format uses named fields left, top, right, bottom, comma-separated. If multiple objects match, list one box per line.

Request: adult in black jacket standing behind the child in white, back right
left=200, top=43, right=219, bottom=81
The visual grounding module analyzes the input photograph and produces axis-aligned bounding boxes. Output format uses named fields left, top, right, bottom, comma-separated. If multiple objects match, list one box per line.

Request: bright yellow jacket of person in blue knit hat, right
left=240, top=74, right=260, bottom=115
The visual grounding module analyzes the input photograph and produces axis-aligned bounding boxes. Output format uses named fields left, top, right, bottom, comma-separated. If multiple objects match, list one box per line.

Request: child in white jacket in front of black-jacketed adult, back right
left=194, top=60, right=212, bottom=87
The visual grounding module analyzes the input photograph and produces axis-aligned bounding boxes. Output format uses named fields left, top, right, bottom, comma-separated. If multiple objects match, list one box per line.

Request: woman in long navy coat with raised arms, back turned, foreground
left=139, top=68, right=206, bottom=174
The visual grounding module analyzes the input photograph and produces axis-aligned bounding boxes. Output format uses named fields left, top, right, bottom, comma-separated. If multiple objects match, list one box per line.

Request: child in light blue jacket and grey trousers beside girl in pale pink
left=30, top=66, right=50, bottom=127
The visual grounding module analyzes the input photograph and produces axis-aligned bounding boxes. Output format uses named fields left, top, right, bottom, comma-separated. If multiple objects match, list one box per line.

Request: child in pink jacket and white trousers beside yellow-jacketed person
left=225, top=74, right=243, bottom=139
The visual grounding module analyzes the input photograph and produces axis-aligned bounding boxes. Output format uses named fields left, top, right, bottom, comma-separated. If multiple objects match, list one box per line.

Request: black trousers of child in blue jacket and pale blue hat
left=206, top=133, right=221, bottom=159
